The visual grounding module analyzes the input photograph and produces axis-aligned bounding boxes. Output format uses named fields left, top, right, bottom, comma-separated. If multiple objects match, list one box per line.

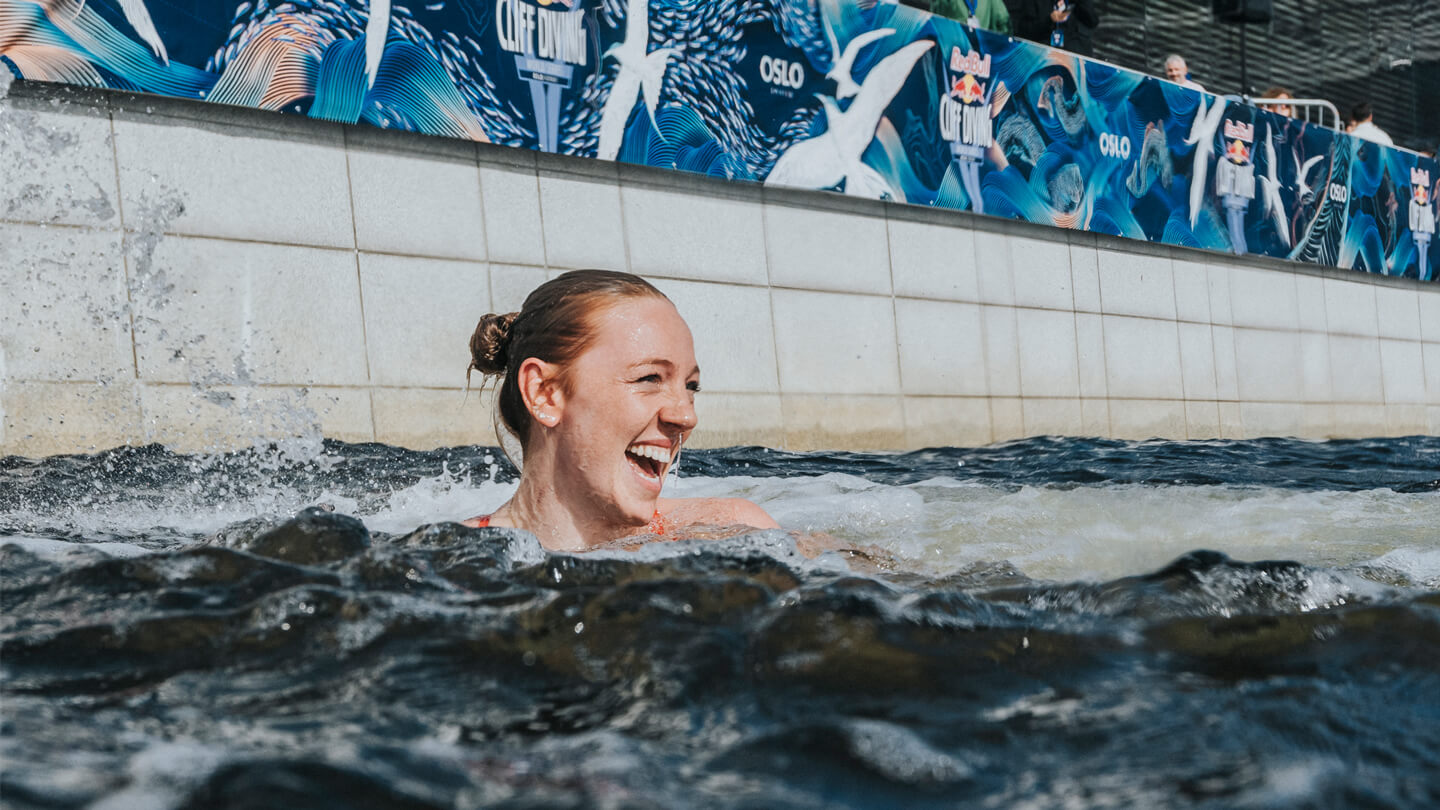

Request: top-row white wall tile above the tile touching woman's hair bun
left=348, top=147, right=485, bottom=259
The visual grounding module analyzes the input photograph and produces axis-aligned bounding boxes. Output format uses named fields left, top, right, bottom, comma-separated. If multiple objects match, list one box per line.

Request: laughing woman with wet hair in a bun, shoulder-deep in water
left=465, top=270, right=778, bottom=551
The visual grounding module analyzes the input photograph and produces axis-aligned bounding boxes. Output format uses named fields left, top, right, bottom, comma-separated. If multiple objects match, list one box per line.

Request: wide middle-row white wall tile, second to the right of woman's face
left=770, top=290, right=900, bottom=392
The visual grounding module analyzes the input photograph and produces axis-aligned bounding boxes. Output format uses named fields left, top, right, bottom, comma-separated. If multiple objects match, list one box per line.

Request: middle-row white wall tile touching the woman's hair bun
left=360, top=254, right=490, bottom=388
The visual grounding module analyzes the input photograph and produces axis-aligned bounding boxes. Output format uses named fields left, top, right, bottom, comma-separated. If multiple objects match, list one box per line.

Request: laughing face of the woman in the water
left=553, top=297, right=700, bottom=526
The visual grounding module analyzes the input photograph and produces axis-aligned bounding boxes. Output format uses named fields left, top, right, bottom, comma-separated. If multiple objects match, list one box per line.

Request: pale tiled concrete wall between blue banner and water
left=8, top=84, right=1440, bottom=455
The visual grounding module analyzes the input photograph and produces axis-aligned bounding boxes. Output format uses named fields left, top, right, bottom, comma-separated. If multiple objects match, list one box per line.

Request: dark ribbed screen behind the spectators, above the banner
left=1094, top=0, right=1440, bottom=148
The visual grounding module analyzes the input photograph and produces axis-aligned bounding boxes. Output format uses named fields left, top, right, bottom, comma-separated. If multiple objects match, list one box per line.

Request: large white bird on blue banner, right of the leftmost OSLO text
left=765, top=39, right=935, bottom=196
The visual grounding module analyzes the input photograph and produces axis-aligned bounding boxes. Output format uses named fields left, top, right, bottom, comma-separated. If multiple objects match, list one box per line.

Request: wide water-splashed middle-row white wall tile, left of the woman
left=130, top=236, right=369, bottom=385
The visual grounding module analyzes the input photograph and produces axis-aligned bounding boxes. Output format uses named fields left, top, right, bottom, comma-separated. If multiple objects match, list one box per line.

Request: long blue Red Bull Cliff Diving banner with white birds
left=0, top=0, right=1440, bottom=280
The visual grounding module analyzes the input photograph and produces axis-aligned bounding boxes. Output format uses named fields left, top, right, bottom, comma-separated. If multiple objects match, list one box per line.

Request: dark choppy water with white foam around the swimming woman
left=0, top=438, right=1440, bottom=810
